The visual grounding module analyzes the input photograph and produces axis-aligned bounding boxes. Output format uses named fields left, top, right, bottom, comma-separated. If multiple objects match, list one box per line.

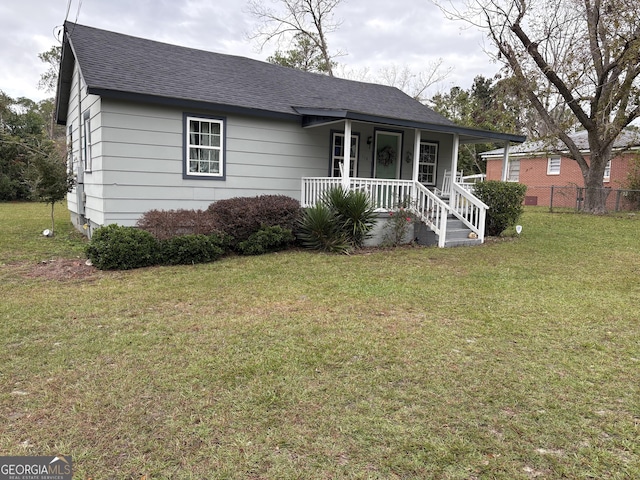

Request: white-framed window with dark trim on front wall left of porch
left=185, top=117, right=225, bottom=178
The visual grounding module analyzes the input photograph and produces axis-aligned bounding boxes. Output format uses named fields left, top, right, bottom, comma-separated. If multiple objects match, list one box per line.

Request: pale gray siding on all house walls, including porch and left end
left=67, top=64, right=460, bottom=229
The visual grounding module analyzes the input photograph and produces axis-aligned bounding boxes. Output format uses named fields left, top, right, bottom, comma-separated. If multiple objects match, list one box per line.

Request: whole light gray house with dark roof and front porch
left=56, top=23, right=524, bottom=246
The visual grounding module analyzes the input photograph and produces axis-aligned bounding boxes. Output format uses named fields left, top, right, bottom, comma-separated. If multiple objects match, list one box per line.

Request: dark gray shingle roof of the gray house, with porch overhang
left=57, top=22, right=524, bottom=142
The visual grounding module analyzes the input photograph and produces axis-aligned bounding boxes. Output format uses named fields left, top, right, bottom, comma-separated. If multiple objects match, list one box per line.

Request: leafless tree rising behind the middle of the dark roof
left=248, top=0, right=342, bottom=76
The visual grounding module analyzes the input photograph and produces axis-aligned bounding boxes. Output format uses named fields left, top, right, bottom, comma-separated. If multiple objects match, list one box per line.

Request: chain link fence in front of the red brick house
left=524, top=185, right=640, bottom=212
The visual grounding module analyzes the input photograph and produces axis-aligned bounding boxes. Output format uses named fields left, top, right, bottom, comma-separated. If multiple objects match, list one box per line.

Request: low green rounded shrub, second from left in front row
left=160, top=234, right=224, bottom=265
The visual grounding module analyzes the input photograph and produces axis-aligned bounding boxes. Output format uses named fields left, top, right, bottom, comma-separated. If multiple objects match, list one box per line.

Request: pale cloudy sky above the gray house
left=0, top=0, right=499, bottom=100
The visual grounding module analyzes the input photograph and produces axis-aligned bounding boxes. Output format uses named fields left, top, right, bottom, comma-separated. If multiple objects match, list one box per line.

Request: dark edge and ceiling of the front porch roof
left=295, top=107, right=527, bottom=144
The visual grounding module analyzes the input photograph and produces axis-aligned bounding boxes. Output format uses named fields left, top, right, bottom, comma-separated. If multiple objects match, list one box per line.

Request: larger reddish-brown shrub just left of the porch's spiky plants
left=207, top=195, right=302, bottom=248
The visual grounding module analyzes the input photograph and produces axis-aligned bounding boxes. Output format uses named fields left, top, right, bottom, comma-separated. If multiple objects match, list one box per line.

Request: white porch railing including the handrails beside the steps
left=300, top=177, right=489, bottom=247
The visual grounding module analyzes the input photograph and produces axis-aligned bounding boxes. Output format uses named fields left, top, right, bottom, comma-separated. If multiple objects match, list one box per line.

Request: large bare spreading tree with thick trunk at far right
left=439, top=0, right=640, bottom=213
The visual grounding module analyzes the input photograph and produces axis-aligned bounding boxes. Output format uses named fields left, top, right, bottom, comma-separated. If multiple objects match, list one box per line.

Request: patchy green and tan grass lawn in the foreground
left=0, top=204, right=640, bottom=480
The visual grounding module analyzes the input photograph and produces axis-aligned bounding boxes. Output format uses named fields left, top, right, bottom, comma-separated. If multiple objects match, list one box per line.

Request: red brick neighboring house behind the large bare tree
left=481, top=130, right=640, bottom=206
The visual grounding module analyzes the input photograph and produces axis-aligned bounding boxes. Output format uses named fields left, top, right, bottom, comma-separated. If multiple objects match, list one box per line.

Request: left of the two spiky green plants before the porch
left=298, top=203, right=350, bottom=253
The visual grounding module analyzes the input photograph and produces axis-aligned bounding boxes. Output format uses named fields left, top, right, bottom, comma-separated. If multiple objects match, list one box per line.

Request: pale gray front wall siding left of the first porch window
left=98, top=98, right=329, bottom=225
